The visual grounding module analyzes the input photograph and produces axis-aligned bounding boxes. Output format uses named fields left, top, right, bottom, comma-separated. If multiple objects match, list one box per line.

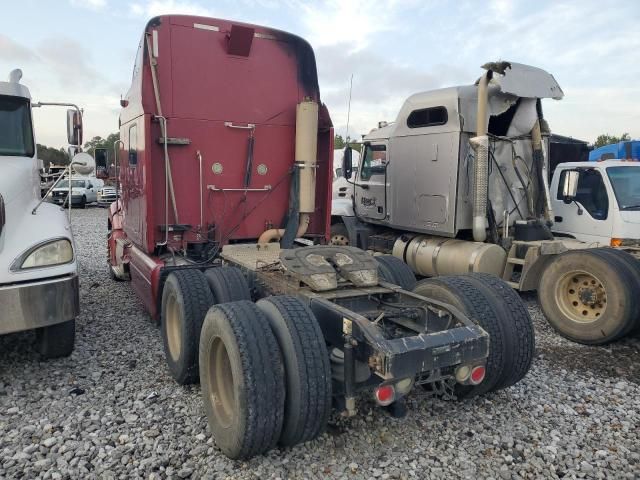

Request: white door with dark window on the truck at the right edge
left=553, top=168, right=613, bottom=245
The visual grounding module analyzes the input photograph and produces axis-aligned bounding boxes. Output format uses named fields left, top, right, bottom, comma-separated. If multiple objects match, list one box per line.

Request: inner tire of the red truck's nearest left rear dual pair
left=256, top=295, right=332, bottom=446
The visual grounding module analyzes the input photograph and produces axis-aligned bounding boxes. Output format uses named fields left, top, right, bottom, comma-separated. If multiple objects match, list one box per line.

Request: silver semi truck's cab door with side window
left=355, top=142, right=388, bottom=220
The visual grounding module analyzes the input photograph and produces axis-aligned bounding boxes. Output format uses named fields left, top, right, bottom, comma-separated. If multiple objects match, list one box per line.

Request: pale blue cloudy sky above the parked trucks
left=0, top=0, right=640, bottom=147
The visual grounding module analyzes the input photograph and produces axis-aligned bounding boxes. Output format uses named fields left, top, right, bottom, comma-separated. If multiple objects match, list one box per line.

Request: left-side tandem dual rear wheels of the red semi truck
left=161, top=267, right=332, bottom=458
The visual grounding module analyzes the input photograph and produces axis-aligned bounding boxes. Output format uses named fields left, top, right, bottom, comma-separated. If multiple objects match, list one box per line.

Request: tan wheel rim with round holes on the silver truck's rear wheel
left=556, top=271, right=607, bottom=324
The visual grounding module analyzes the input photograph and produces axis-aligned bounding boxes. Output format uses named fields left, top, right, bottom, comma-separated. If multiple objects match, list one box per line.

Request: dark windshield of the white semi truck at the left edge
left=0, top=95, right=34, bottom=157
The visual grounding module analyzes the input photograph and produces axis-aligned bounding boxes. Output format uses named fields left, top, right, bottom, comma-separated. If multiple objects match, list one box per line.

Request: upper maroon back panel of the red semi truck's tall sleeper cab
left=166, top=23, right=299, bottom=125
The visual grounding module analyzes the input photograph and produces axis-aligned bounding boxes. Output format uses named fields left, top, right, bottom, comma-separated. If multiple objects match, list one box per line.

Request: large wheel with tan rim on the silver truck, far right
left=538, top=249, right=638, bottom=345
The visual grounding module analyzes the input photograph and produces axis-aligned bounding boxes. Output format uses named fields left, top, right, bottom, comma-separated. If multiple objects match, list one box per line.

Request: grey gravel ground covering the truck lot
left=0, top=208, right=640, bottom=479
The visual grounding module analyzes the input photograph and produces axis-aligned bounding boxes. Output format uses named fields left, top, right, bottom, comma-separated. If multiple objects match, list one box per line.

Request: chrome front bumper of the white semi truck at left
left=0, top=274, right=80, bottom=334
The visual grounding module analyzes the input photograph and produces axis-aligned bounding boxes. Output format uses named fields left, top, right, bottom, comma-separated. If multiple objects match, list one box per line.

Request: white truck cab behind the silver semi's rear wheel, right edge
left=551, top=160, right=640, bottom=247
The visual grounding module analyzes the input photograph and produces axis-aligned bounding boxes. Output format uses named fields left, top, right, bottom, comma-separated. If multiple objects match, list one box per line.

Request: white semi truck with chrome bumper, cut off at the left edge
left=0, top=70, right=82, bottom=358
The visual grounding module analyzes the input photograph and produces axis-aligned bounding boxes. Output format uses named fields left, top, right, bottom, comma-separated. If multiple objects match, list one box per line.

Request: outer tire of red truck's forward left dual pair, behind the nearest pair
left=160, top=269, right=214, bottom=385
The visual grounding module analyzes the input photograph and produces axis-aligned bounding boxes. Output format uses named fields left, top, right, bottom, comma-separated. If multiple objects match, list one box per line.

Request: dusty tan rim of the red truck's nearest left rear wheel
left=208, top=337, right=236, bottom=428
